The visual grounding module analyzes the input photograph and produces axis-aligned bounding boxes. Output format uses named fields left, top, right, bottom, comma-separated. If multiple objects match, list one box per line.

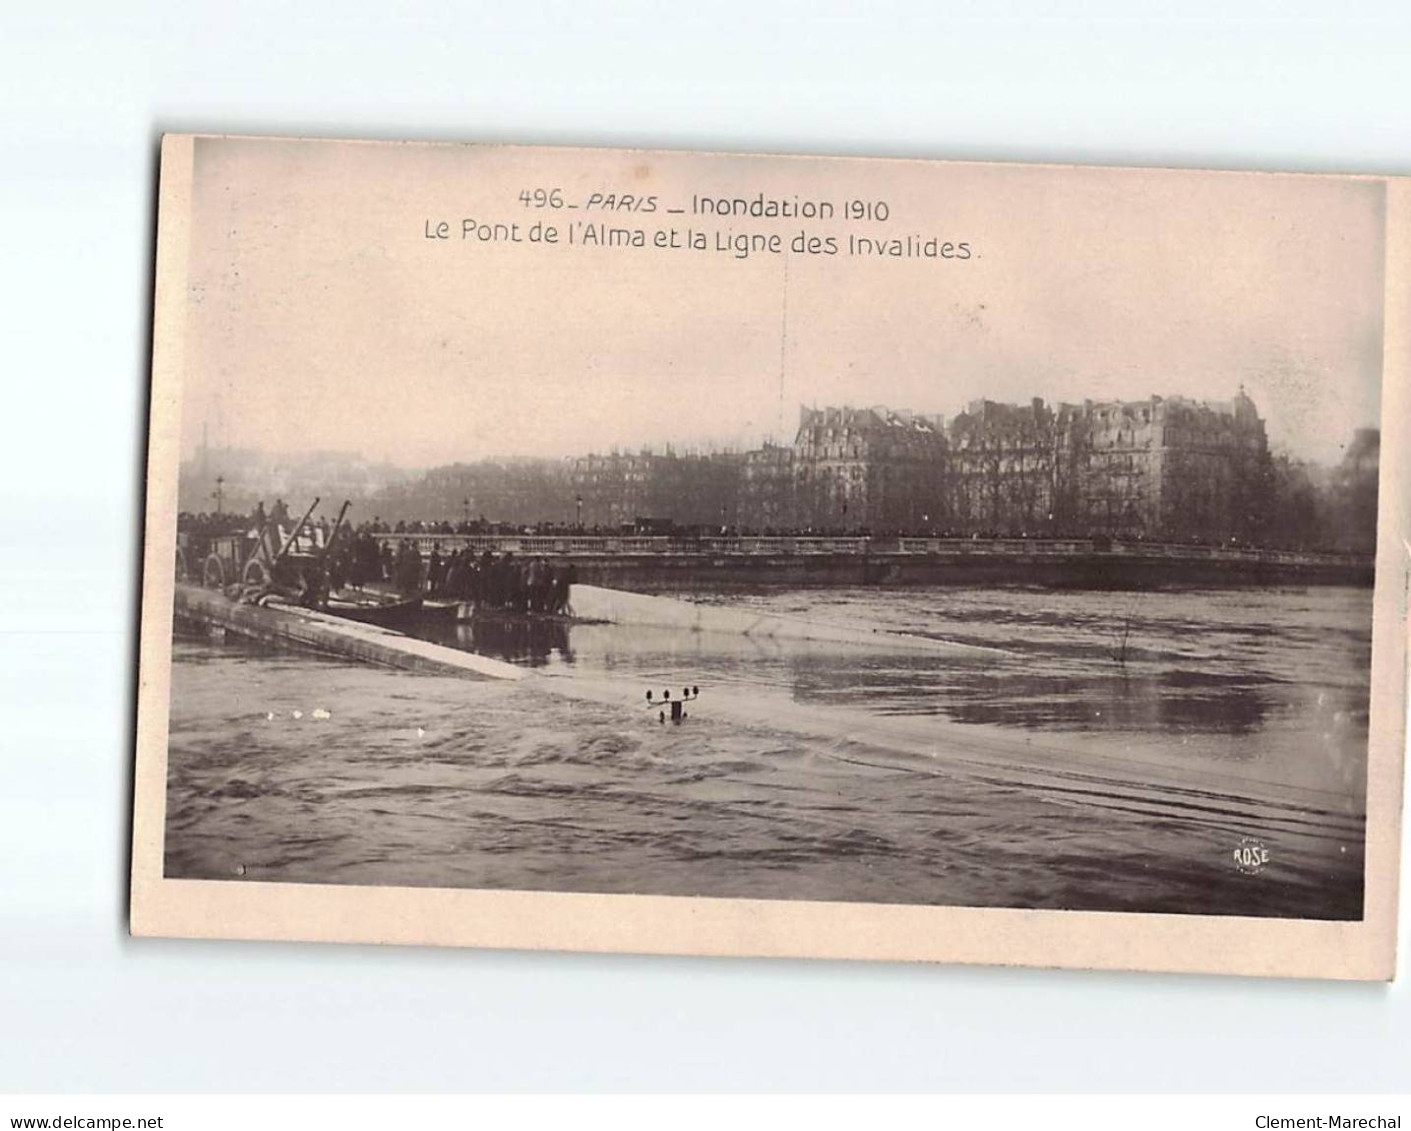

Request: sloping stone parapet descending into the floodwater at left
left=172, top=582, right=525, bottom=680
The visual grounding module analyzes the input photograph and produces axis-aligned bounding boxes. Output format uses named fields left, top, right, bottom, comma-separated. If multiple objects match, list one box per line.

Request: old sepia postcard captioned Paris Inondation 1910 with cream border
left=133, top=137, right=1405, bottom=977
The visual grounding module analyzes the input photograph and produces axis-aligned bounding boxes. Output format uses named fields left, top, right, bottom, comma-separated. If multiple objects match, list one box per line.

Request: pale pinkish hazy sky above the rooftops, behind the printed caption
left=173, top=140, right=1383, bottom=467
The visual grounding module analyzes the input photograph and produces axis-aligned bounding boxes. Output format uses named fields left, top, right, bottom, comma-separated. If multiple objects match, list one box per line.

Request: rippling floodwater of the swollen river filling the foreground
left=166, top=587, right=1371, bottom=918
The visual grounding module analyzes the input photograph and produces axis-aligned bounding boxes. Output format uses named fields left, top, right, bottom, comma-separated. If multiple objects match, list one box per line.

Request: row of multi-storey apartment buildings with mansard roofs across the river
left=567, top=389, right=1271, bottom=540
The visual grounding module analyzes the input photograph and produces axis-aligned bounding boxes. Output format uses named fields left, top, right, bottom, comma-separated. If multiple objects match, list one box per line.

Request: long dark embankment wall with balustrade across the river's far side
left=374, top=532, right=1374, bottom=591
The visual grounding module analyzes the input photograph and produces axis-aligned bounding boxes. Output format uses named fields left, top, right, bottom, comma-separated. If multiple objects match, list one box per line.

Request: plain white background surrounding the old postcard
left=0, top=0, right=1411, bottom=1092
